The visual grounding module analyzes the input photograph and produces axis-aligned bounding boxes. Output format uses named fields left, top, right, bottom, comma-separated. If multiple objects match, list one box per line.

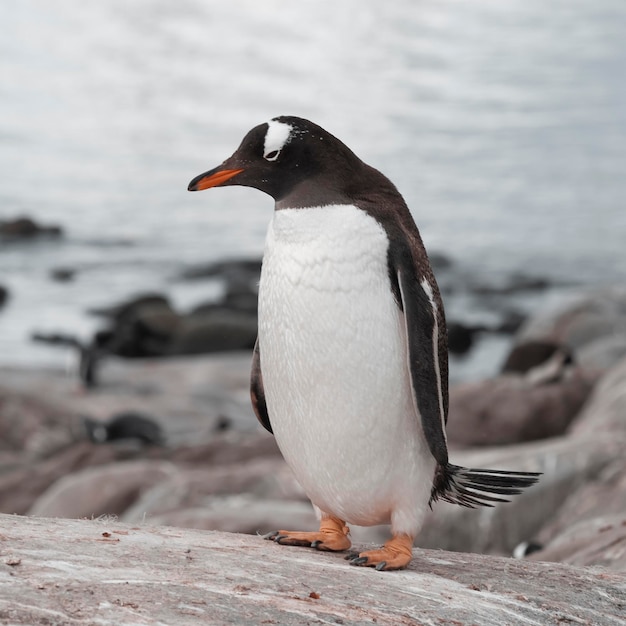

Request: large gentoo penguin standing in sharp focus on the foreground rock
left=189, top=116, right=537, bottom=570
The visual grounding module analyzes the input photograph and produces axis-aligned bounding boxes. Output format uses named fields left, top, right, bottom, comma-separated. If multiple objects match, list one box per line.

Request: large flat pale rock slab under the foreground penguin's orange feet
left=0, top=515, right=626, bottom=626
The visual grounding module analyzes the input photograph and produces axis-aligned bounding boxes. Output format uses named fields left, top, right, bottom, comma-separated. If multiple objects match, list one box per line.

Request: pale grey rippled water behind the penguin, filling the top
left=0, top=0, right=626, bottom=378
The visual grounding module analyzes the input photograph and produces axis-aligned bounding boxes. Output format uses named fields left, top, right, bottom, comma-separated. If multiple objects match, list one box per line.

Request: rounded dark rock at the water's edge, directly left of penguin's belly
left=168, top=308, right=257, bottom=355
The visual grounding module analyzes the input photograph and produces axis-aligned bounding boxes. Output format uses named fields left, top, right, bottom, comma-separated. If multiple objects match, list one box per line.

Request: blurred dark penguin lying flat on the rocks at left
left=82, top=411, right=165, bottom=446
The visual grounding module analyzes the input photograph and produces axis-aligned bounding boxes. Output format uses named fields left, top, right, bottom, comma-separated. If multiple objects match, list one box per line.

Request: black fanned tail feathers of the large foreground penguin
left=429, top=463, right=541, bottom=508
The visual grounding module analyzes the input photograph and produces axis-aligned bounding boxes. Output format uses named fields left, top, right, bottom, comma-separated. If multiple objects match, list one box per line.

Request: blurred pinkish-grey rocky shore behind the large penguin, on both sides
left=0, top=289, right=626, bottom=571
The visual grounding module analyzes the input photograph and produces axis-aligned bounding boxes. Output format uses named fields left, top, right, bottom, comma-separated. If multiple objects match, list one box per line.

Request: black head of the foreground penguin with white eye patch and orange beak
left=188, top=116, right=367, bottom=204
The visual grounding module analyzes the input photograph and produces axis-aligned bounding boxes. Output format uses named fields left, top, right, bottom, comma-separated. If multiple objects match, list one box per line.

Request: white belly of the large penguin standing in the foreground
left=259, top=205, right=435, bottom=532
